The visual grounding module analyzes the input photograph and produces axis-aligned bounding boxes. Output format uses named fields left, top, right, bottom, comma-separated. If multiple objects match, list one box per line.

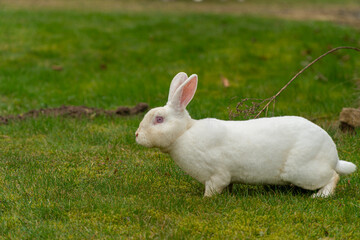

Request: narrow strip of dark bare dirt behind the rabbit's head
left=0, top=103, right=149, bottom=124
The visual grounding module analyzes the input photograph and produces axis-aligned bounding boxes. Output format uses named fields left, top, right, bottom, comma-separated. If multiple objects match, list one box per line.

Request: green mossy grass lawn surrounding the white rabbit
left=0, top=1, right=360, bottom=239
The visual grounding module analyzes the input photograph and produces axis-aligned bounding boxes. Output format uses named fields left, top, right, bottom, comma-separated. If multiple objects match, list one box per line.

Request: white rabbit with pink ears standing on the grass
left=135, top=73, right=356, bottom=197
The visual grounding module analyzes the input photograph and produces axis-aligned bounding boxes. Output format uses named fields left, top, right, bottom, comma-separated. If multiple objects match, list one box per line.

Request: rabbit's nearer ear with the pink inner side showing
left=168, top=74, right=198, bottom=111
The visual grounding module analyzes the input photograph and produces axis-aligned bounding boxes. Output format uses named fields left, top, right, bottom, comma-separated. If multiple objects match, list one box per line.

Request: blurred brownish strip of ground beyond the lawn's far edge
left=0, top=0, right=360, bottom=28
